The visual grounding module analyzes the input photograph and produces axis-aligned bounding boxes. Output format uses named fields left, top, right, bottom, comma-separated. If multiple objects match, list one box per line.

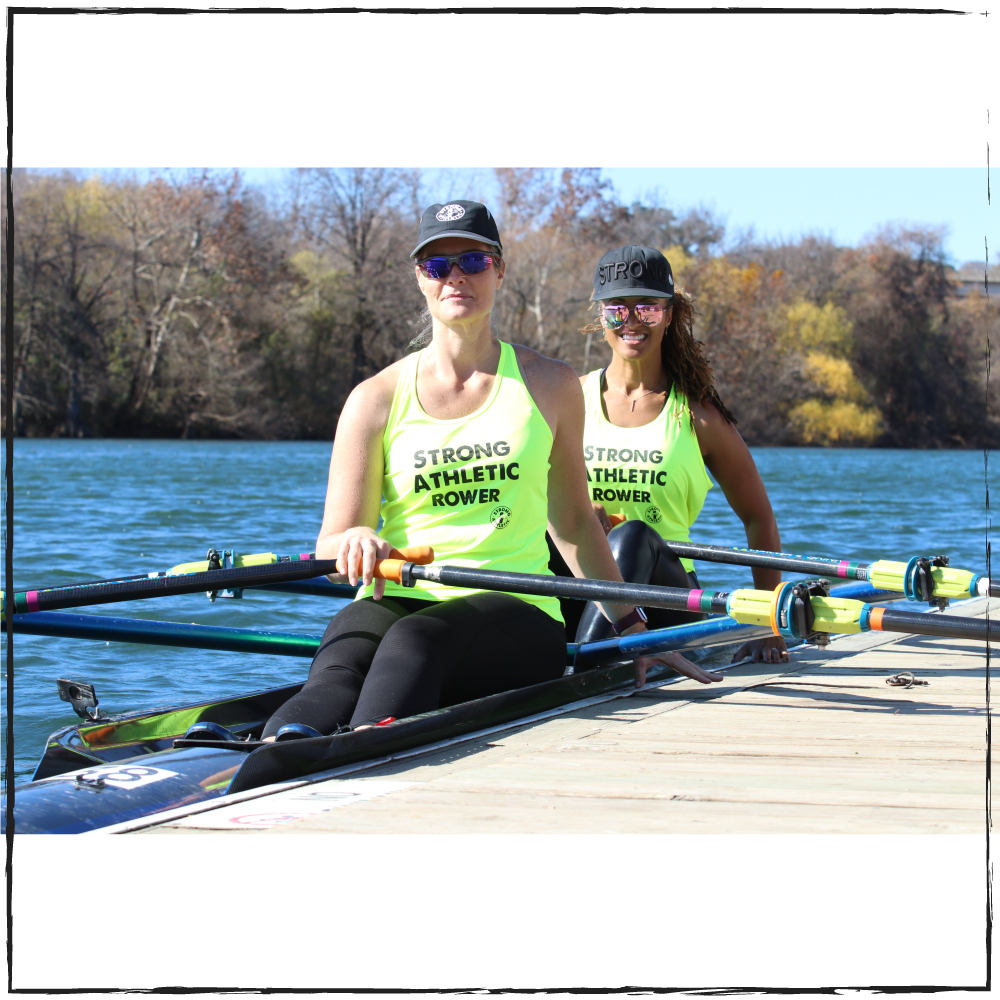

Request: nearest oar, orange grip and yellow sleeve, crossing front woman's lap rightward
left=378, top=560, right=1000, bottom=643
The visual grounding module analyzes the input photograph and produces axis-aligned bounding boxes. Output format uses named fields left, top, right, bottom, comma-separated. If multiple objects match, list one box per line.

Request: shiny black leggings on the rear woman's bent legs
left=546, top=521, right=705, bottom=642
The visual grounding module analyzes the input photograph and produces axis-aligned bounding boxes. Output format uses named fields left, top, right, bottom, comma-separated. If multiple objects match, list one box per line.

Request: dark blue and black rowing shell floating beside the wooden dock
left=3, top=648, right=720, bottom=833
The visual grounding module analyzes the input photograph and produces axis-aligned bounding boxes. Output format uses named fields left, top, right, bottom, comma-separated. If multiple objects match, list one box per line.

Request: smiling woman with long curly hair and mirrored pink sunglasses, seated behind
left=552, top=246, right=788, bottom=662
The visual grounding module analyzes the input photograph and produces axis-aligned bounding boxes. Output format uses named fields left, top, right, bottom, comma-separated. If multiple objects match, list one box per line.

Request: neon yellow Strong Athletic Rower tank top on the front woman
left=358, top=342, right=563, bottom=622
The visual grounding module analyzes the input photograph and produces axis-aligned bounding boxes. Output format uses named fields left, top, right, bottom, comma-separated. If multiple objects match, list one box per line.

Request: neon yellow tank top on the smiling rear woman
left=583, top=371, right=712, bottom=573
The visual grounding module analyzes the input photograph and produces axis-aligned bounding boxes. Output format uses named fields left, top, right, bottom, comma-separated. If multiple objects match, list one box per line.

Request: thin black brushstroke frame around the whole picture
left=3, top=7, right=993, bottom=996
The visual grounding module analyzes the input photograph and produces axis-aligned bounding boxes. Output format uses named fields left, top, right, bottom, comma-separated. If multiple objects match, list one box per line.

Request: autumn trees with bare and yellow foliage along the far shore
left=3, top=168, right=1000, bottom=448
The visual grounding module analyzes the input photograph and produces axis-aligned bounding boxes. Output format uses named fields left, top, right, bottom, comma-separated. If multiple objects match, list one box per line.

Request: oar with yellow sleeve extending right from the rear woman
left=609, top=514, right=1000, bottom=601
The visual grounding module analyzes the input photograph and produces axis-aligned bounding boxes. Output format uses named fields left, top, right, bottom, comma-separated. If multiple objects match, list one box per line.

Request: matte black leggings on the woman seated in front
left=262, top=593, right=566, bottom=736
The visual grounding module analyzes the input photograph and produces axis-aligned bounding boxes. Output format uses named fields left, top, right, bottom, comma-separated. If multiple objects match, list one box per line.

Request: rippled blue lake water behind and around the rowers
left=4, top=440, right=997, bottom=782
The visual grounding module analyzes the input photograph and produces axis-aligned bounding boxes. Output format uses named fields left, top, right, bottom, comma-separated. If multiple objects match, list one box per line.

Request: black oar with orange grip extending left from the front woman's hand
left=0, top=545, right=434, bottom=614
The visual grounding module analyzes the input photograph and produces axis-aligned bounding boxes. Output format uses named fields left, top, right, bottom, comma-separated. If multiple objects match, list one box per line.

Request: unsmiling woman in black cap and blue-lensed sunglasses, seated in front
left=264, top=213, right=721, bottom=739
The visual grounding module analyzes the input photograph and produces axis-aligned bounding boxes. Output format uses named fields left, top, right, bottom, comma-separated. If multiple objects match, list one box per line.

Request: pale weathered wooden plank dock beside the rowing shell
left=136, top=599, right=1000, bottom=834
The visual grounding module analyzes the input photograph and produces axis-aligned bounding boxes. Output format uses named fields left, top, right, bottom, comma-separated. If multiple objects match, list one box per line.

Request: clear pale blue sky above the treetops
left=86, top=167, right=1000, bottom=266
